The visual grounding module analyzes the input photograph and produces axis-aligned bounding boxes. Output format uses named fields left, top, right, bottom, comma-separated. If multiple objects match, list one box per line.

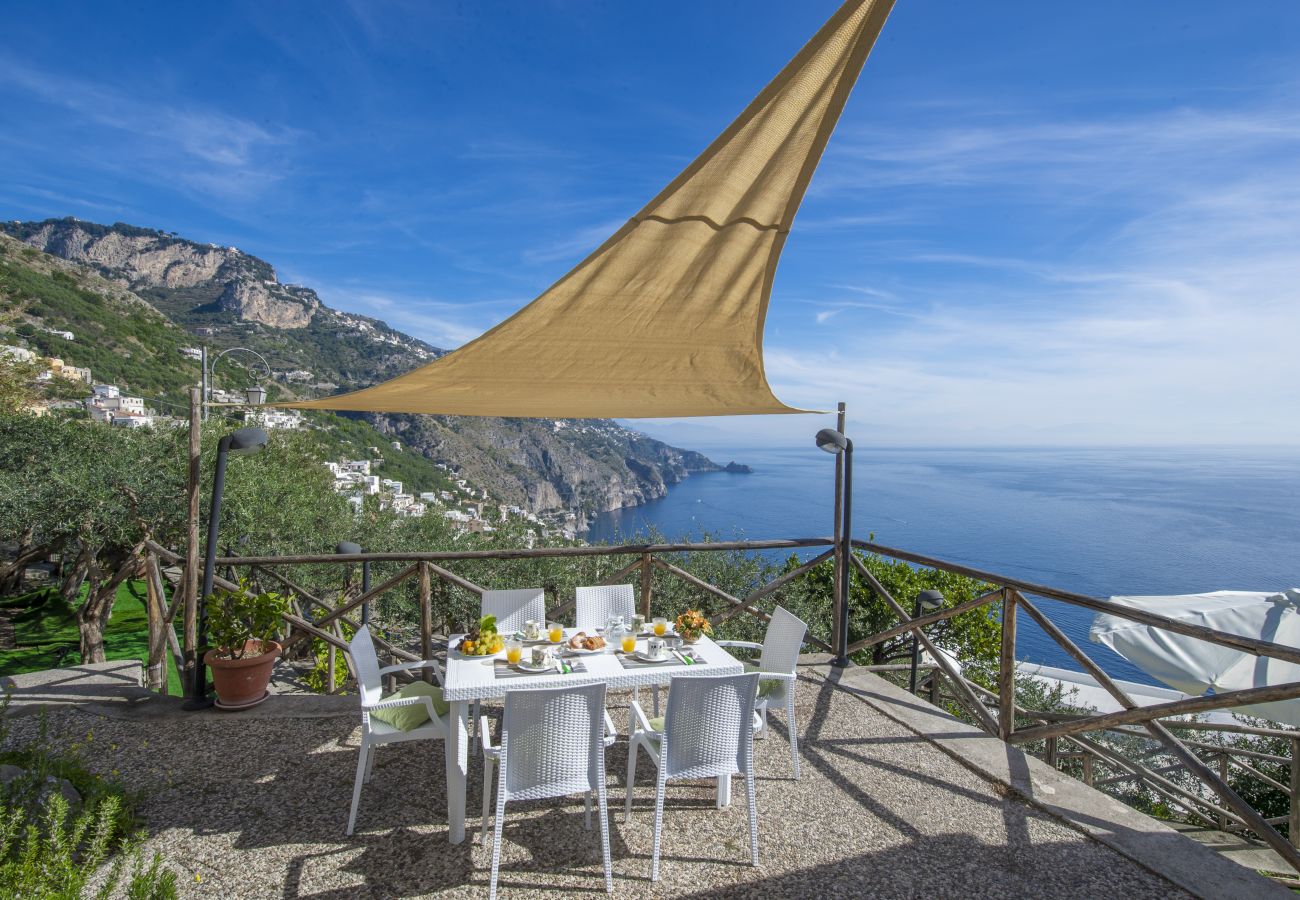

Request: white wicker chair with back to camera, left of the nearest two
left=478, top=683, right=614, bottom=899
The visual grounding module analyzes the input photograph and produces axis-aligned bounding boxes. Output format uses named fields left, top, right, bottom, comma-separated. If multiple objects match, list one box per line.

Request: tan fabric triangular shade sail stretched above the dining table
left=290, top=0, right=893, bottom=419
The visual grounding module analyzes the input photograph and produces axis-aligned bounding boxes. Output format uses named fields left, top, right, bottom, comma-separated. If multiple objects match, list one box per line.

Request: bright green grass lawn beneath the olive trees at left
left=0, top=581, right=181, bottom=696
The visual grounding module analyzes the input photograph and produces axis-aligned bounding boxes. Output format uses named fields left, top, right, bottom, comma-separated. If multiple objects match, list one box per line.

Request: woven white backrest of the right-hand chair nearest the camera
left=662, top=672, right=758, bottom=778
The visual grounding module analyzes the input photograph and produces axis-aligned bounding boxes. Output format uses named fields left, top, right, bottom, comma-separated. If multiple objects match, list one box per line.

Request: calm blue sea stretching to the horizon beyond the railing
left=586, top=441, right=1300, bottom=683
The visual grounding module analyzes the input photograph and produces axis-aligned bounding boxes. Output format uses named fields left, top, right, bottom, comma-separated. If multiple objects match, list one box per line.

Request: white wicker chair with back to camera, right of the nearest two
left=625, top=672, right=758, bottom=882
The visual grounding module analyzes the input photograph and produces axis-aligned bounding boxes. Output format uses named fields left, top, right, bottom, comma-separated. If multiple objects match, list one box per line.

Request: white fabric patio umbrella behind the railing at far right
left=1089, top=588, right=1300, bottom=726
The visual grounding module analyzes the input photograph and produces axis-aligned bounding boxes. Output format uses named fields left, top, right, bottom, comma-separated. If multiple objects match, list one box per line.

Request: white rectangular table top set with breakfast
left=442, top=628, right=745, bottom=701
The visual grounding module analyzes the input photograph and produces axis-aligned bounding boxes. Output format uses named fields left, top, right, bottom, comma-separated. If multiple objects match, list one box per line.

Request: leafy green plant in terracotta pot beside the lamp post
left=203, top=579, right=289, bottom=709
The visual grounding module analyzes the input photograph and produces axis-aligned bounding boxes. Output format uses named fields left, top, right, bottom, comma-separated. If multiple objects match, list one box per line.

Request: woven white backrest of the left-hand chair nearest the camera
left=498, top=682, right=605, bottom=800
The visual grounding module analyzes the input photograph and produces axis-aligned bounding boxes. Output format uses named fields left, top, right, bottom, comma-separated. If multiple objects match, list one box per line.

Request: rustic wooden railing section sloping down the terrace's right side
left=849, top=541, right=1300, bottom=871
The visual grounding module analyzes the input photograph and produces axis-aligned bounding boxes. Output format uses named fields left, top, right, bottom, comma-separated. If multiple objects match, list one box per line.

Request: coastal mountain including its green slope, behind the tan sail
left=0, top=218, right=722, bottom=515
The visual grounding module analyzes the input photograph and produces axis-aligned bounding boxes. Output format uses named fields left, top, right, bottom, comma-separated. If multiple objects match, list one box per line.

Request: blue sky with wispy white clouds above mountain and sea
left=0, top=0, right=1300, bottom=445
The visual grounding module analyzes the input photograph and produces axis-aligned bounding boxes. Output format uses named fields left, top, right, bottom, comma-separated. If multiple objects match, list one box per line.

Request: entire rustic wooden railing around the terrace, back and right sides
left=146, top=537, right=1300, bottom=871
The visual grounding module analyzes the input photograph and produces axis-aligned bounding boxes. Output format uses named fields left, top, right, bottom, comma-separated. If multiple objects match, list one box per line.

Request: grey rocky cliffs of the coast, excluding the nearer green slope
left=0, top=218, right=743, bottom=516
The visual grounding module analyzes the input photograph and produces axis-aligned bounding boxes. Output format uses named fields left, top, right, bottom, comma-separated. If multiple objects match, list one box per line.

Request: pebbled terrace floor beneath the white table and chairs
left=0, top=665, right=1282, bottom=900
